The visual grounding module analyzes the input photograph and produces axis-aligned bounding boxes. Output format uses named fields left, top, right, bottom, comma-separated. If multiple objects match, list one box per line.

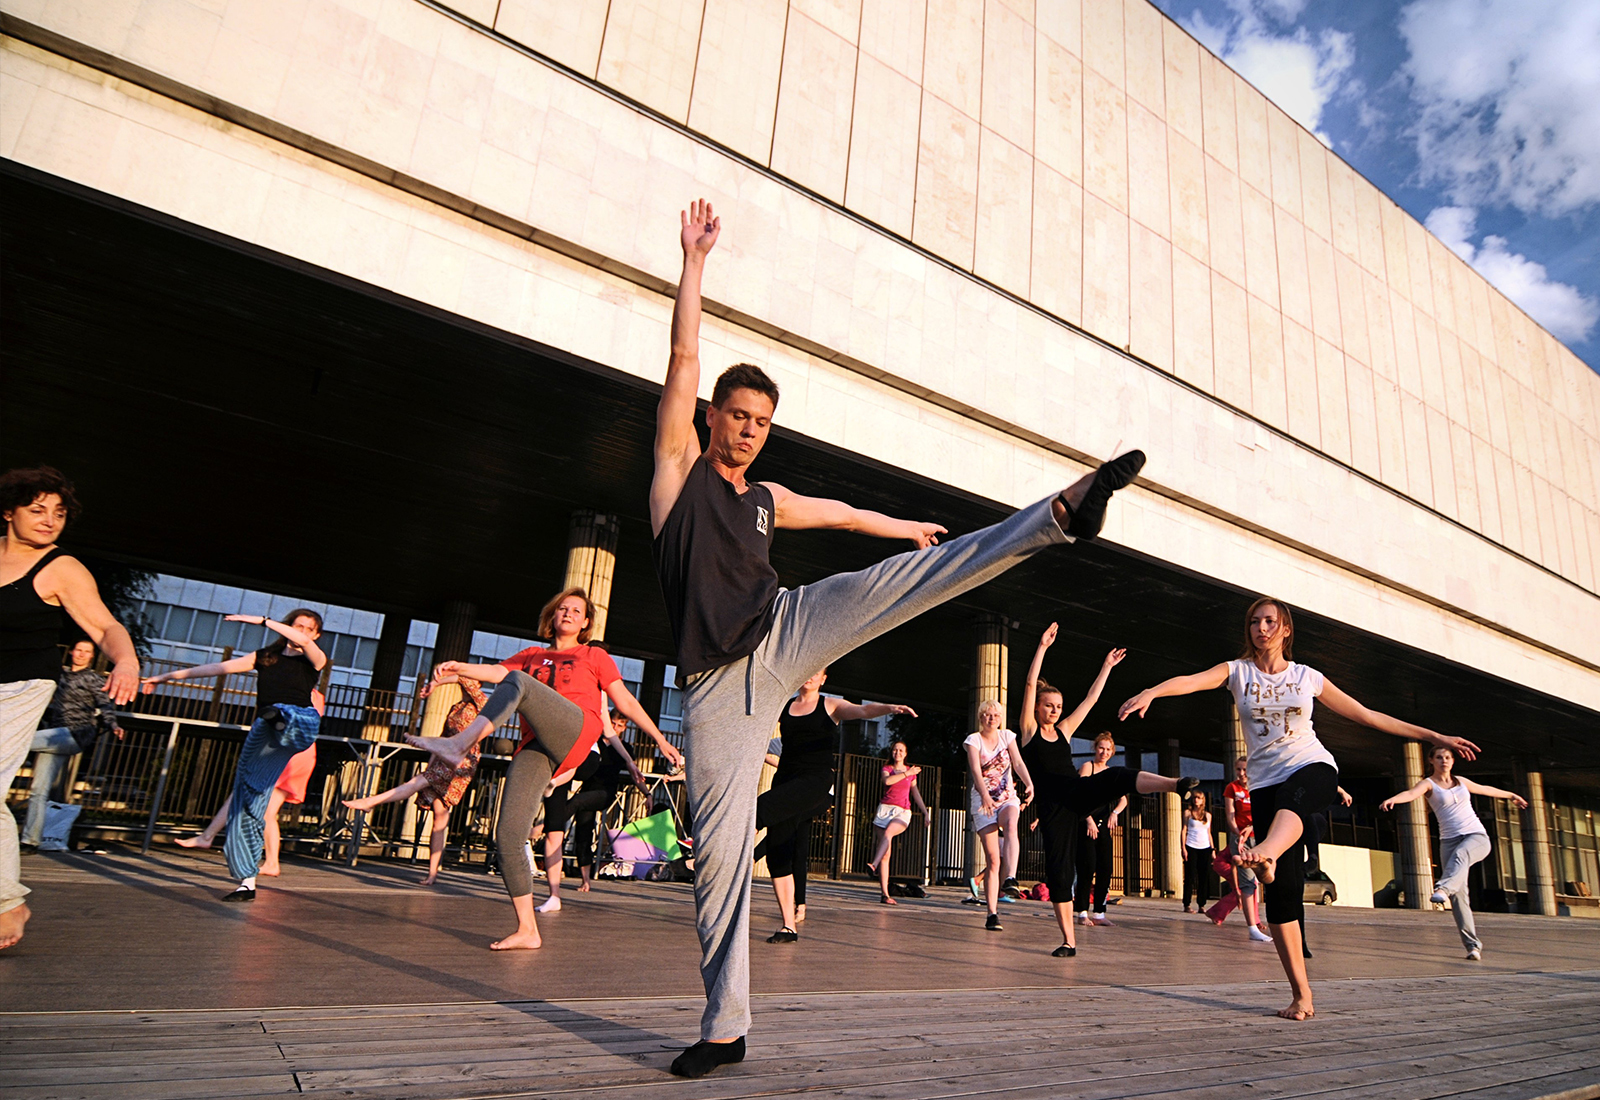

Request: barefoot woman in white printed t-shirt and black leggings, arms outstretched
left=1118, top=596, right=1478, bottom=1020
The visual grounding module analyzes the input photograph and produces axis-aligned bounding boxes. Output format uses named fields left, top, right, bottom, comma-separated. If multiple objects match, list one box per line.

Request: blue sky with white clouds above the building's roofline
left=1154, top=0, right=1600, bottom=371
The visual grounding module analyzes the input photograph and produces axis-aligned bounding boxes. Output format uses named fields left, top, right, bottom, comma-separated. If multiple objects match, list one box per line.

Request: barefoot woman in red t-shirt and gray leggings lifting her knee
left=406, top=588, right=682, bottom=951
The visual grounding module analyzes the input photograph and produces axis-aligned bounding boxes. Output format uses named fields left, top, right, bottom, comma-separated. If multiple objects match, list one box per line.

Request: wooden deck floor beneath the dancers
left=0, top=857, right=1600, bottom=1100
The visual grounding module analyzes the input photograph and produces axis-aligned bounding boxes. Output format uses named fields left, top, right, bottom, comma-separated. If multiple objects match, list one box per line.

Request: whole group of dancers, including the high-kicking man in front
left=0, top=201, right=1520, bottom=1078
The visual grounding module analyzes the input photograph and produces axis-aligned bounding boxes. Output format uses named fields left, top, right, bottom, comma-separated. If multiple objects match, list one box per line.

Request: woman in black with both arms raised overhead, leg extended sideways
left=1022, top=624, right=1200, bottom=958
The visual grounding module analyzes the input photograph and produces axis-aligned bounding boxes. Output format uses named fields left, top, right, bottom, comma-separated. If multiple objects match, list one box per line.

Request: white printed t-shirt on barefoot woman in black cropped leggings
left=1227, top=660, right=1339, bottom=790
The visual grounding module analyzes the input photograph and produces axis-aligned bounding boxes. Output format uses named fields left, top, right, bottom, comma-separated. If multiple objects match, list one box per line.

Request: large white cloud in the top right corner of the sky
left=1400, top=0, right=1600, bottom=214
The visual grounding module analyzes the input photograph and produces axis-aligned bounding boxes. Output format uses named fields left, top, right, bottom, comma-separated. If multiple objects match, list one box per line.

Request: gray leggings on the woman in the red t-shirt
left=478, top=672, right=584, bottom=899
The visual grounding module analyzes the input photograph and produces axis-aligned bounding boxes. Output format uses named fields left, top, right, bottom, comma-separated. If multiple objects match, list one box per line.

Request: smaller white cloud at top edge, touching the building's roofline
left=1182, top=0, right=1355, bottom=145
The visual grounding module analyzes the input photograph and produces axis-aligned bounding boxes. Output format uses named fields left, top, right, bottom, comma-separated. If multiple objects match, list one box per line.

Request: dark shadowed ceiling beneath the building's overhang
left=0, top=161, right=1600, bottom=785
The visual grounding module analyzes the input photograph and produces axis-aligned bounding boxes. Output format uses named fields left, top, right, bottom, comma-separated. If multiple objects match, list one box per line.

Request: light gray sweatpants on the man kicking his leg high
left=683, top=499, right=1070, bottom=1039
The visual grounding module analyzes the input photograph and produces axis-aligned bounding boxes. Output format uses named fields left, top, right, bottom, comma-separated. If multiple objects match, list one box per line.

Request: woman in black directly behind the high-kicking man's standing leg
left=755, top=668, right=917, bottom=943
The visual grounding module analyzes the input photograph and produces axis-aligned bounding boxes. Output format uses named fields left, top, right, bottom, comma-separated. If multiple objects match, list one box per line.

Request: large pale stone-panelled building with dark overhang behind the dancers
left=0, top=0, right=1600, bottom=911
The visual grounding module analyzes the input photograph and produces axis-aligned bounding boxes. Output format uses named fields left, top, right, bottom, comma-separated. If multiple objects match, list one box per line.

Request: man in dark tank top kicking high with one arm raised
left=650, top=200, right=1144, bottom=1078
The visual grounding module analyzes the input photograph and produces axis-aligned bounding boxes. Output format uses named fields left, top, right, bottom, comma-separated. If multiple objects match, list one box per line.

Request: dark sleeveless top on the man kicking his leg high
left=651, top=454, right=778, bottom=677
